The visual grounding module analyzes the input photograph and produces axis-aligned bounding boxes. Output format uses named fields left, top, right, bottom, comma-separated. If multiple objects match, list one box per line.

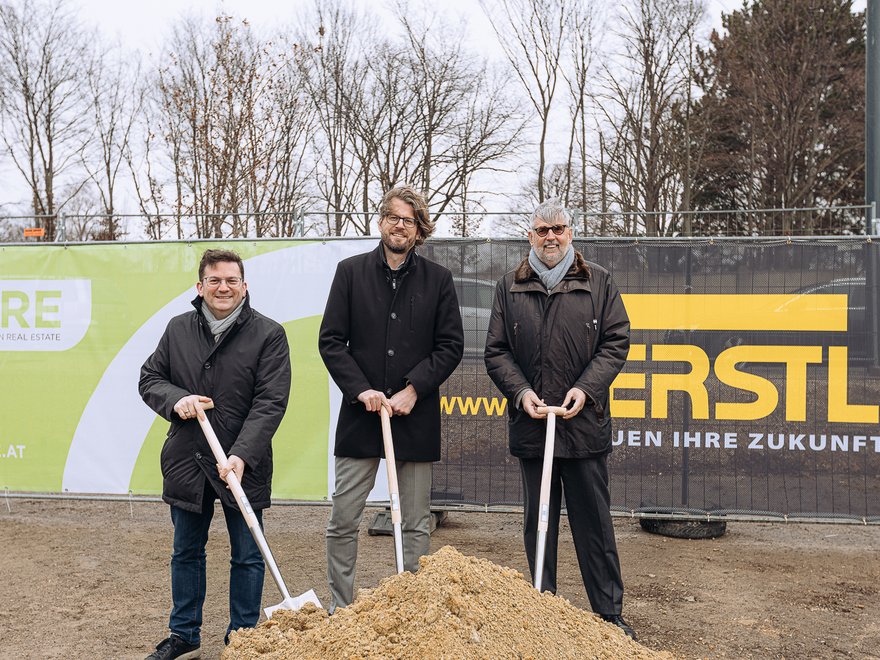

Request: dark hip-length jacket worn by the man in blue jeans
left=138, top=294, right=290, bottom=511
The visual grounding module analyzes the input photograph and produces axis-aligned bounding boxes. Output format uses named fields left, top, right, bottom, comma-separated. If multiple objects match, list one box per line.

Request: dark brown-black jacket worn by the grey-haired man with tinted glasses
left=485, top=252, right=629, bottom=458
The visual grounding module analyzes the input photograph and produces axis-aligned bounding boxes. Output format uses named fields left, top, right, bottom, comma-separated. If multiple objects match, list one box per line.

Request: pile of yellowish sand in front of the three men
left=222, top=546, right=671, bottom=660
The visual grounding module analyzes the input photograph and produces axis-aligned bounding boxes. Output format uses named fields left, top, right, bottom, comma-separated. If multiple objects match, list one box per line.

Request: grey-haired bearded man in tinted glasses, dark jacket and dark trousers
left=485, top=201, right=635, bottom=639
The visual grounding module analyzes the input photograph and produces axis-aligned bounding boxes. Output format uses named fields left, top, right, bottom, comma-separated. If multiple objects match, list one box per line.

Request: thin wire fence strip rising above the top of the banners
left=0, top=204, right=880, bottom=242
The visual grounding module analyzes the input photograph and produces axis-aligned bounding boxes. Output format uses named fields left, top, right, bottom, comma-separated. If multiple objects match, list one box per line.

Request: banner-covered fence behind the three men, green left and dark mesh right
left=0, top=236, right=880, bottom=524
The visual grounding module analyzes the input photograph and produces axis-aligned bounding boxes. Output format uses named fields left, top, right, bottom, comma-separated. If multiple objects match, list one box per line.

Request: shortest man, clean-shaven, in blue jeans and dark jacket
left=138, top=250, right=290, bottom=660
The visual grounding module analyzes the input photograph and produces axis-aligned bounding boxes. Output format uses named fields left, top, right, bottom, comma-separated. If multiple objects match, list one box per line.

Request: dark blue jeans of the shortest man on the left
left=168, top=484, right=266, bottom=644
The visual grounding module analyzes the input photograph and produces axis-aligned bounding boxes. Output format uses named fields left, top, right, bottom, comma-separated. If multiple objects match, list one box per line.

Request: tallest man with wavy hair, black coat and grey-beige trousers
left=318, top=186, right=464, bottom=613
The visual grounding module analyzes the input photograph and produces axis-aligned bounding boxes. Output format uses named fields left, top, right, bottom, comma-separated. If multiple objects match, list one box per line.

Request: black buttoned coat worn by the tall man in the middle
left=318, top=243, right=464, bottom=461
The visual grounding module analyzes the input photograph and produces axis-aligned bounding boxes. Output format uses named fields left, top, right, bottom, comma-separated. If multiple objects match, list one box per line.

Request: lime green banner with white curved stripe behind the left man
left=0, top=240, right=375, bottom=499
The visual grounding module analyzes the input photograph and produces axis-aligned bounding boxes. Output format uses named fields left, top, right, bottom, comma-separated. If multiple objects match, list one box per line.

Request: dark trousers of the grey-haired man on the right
left=520, top=456, right=623, bottom=614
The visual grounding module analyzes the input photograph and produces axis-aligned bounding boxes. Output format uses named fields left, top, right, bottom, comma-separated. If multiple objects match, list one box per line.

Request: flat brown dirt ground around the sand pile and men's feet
left=0, top=498, right=880, bottom=659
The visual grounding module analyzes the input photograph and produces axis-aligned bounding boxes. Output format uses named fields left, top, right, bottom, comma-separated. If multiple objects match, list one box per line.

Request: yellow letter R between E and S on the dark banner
left=651, top=344, right=709, bottom=419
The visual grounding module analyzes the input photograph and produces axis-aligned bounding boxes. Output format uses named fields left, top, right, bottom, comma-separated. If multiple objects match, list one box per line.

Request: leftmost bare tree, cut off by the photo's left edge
left=0, top=0, right=93, bottom=241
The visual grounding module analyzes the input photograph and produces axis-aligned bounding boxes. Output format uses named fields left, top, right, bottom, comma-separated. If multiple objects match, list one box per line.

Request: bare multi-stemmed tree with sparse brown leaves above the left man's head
left=139, top=15, right=314, bottom=238
